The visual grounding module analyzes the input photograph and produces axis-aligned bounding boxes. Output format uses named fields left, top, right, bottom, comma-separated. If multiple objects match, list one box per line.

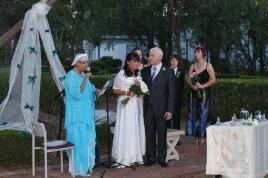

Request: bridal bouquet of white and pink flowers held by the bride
left=121, top=80, right=149, bottom=106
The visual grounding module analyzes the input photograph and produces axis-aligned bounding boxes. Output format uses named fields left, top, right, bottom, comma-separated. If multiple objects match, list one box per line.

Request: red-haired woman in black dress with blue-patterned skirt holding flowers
left=186, top=47, right=216, bottom=145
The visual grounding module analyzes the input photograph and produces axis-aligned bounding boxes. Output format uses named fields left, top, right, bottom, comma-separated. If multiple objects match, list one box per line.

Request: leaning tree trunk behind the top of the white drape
left=0, top=0, right=59, bottom=48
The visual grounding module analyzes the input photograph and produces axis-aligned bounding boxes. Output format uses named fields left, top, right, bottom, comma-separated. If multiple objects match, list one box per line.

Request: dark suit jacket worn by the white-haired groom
left=141, top=65, right=175, bottom=117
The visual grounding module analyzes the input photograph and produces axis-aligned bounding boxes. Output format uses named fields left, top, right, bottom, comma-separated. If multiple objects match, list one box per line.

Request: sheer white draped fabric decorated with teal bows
left=0, top=2, right=66, bottom=131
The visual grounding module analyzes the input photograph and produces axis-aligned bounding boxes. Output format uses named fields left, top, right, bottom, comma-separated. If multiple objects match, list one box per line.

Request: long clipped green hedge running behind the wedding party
left=0, top=72, right=268, bottom=120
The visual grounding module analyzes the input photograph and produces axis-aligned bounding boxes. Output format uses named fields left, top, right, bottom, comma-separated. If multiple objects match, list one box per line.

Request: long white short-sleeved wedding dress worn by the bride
left=112, top=70, right=148, bottom=166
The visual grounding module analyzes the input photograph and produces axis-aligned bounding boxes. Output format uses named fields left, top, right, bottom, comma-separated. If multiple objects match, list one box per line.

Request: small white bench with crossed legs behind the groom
left=166, top=129, right=185, bottom=162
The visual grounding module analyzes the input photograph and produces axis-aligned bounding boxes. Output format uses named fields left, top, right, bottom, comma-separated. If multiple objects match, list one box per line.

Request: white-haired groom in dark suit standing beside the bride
left=141, top=47, right=175, bottom=167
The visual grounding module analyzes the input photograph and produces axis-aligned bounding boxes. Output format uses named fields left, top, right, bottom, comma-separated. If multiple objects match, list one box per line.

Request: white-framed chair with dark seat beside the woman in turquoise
left=32, top=122, right=75, bottom=178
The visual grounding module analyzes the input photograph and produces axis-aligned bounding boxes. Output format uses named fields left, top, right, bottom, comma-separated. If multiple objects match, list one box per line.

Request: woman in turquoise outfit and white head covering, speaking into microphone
left=64, top=54, right=99, bottom=176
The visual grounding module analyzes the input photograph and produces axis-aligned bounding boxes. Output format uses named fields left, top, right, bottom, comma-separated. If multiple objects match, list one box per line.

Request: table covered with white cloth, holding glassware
left=206, top=121, right=268, bottom=178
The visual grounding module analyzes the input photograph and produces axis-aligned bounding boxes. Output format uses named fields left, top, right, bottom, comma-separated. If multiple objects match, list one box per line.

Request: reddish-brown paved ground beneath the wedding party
left=0, top=137, right=212, bottom=178
